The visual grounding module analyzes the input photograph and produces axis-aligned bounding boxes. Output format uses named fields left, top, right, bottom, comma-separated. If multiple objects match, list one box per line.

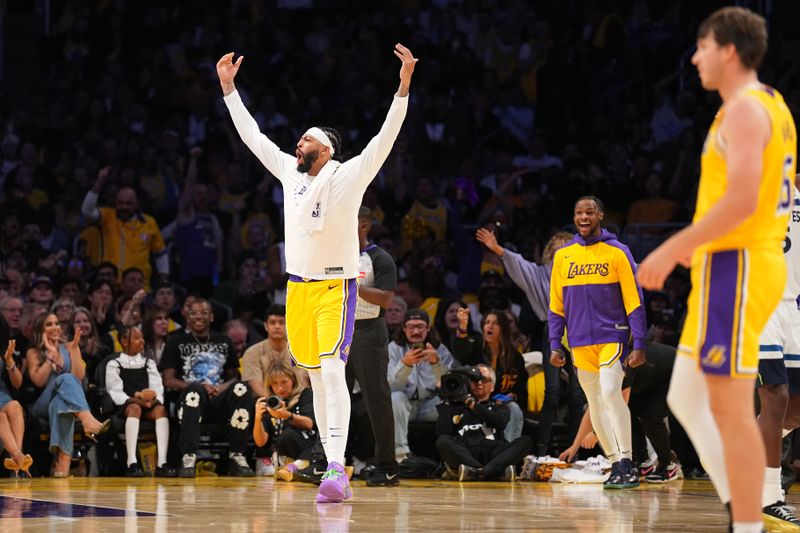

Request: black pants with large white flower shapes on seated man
left=178, top=381, right=253, bottom=454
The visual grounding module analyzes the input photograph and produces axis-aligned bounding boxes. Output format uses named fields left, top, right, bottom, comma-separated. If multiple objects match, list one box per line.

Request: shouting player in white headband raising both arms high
left=217, top=44, right=417, bottom=503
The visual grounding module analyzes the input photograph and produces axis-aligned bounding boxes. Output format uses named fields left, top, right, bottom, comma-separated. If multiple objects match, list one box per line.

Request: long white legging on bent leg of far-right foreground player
left=667, top=354, right=728, bottom=502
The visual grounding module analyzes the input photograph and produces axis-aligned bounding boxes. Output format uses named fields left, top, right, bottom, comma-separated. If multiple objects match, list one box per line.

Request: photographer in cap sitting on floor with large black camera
left=436, top=364, right=533, bottom=481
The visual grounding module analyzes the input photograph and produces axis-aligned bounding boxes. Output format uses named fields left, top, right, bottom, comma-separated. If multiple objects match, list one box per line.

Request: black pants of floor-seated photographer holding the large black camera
left=436, top=435, right=533, bottom=479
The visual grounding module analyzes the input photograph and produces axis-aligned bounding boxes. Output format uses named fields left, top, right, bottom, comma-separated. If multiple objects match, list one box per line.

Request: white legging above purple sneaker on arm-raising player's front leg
left=322, top=357, right=350, bottom=466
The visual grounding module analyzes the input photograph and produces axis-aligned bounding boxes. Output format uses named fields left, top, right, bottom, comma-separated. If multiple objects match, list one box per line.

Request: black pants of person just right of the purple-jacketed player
left=628, top=381, right=671, bottom=467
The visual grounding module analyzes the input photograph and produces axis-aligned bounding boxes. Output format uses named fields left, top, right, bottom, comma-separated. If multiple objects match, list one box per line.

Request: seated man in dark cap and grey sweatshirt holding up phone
left=388, top=309, right=453, bottom=461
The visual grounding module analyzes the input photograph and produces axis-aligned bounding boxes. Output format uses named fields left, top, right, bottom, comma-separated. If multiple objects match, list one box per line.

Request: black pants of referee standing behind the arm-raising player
left=345, top=318, right=397, bottom=472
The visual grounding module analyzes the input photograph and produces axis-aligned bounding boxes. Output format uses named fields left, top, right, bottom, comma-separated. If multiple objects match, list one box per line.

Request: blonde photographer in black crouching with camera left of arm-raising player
left=253, top=361, right=317, bottom=481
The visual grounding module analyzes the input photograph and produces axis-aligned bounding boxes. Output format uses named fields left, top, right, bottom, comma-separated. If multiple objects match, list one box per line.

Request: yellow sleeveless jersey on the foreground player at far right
left=694, top=84, right=797, bottom=252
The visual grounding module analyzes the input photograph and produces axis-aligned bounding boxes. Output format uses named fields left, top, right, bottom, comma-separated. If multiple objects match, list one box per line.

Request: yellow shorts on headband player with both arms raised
left=286, top=276, right=358, bottom=368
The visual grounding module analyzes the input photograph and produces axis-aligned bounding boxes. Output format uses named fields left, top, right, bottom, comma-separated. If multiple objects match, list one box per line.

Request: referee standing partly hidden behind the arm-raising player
left=346, top=206, right=400, bottom=487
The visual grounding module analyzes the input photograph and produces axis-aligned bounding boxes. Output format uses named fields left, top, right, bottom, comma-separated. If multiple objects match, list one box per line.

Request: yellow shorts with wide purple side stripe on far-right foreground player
left=678, top=248, right=786, bottom=378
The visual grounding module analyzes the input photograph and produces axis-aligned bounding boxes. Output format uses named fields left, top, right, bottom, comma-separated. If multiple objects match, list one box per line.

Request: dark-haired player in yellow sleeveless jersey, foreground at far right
left=637, top=7, right=797, bottom=533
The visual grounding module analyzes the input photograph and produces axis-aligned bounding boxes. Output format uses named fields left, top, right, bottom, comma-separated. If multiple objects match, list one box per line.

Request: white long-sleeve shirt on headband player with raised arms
left=225, top=91, right=408, bottom=279
